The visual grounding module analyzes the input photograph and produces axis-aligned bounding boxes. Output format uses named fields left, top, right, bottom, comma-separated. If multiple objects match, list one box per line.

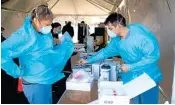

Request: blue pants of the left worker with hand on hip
left=23, top=84, right=52, bottom=104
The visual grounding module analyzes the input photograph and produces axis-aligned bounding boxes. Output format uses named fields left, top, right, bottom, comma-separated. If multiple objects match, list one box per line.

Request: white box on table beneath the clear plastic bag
left=66, top=75, right=94, bottom=91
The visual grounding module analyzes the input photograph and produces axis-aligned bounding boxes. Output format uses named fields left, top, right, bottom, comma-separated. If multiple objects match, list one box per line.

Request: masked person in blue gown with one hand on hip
left=1, top=5, right=74, bottom=104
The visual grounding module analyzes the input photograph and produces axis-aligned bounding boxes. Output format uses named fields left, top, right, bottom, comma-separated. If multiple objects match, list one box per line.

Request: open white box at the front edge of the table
left=98, top=80, right=130, bottom=104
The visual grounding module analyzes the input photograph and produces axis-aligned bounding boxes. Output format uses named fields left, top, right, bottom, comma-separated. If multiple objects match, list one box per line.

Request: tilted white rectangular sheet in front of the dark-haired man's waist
left=124, top=73, right=156, bottom=99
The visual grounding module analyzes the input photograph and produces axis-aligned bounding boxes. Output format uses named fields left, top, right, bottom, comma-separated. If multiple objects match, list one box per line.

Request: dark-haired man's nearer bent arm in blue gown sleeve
left=127, top=33, right=160, bottom=70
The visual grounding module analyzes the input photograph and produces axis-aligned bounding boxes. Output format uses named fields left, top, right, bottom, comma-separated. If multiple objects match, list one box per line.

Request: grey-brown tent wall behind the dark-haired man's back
left=119, top=0, right=175, bottom=99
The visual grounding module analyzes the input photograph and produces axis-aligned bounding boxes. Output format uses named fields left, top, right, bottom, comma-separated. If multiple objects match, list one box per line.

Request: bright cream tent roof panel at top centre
left=48, top=0, right=110, bottom=15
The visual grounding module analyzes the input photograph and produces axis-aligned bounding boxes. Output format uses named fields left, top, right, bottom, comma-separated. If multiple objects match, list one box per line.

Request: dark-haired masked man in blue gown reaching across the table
left=80, top=13, right=162, bottom=104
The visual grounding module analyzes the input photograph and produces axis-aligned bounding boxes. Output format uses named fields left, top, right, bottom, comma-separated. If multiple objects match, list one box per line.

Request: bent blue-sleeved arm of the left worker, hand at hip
left=1, top=30, right=28, bottom=78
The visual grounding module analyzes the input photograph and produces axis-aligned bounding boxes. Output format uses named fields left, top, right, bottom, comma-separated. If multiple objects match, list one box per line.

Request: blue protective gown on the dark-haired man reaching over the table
left=87, top=24, right=162, bottom=83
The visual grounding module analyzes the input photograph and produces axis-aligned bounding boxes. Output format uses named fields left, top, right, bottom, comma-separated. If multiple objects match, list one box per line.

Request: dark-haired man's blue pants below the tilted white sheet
left=131, top=85, right=159, bottom=104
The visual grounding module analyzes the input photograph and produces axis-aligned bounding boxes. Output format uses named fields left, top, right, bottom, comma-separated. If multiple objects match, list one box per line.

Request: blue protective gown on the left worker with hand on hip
left=1, top=16, right=74, bottom=84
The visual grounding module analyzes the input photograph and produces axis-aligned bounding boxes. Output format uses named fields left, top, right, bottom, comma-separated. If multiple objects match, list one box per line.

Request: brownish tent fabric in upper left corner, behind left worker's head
left=1, top=0, right=49, bottom=37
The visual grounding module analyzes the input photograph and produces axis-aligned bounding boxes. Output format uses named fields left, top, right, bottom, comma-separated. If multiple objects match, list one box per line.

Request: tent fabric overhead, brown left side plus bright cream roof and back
left=1, top=0, right=122, bottom=37
